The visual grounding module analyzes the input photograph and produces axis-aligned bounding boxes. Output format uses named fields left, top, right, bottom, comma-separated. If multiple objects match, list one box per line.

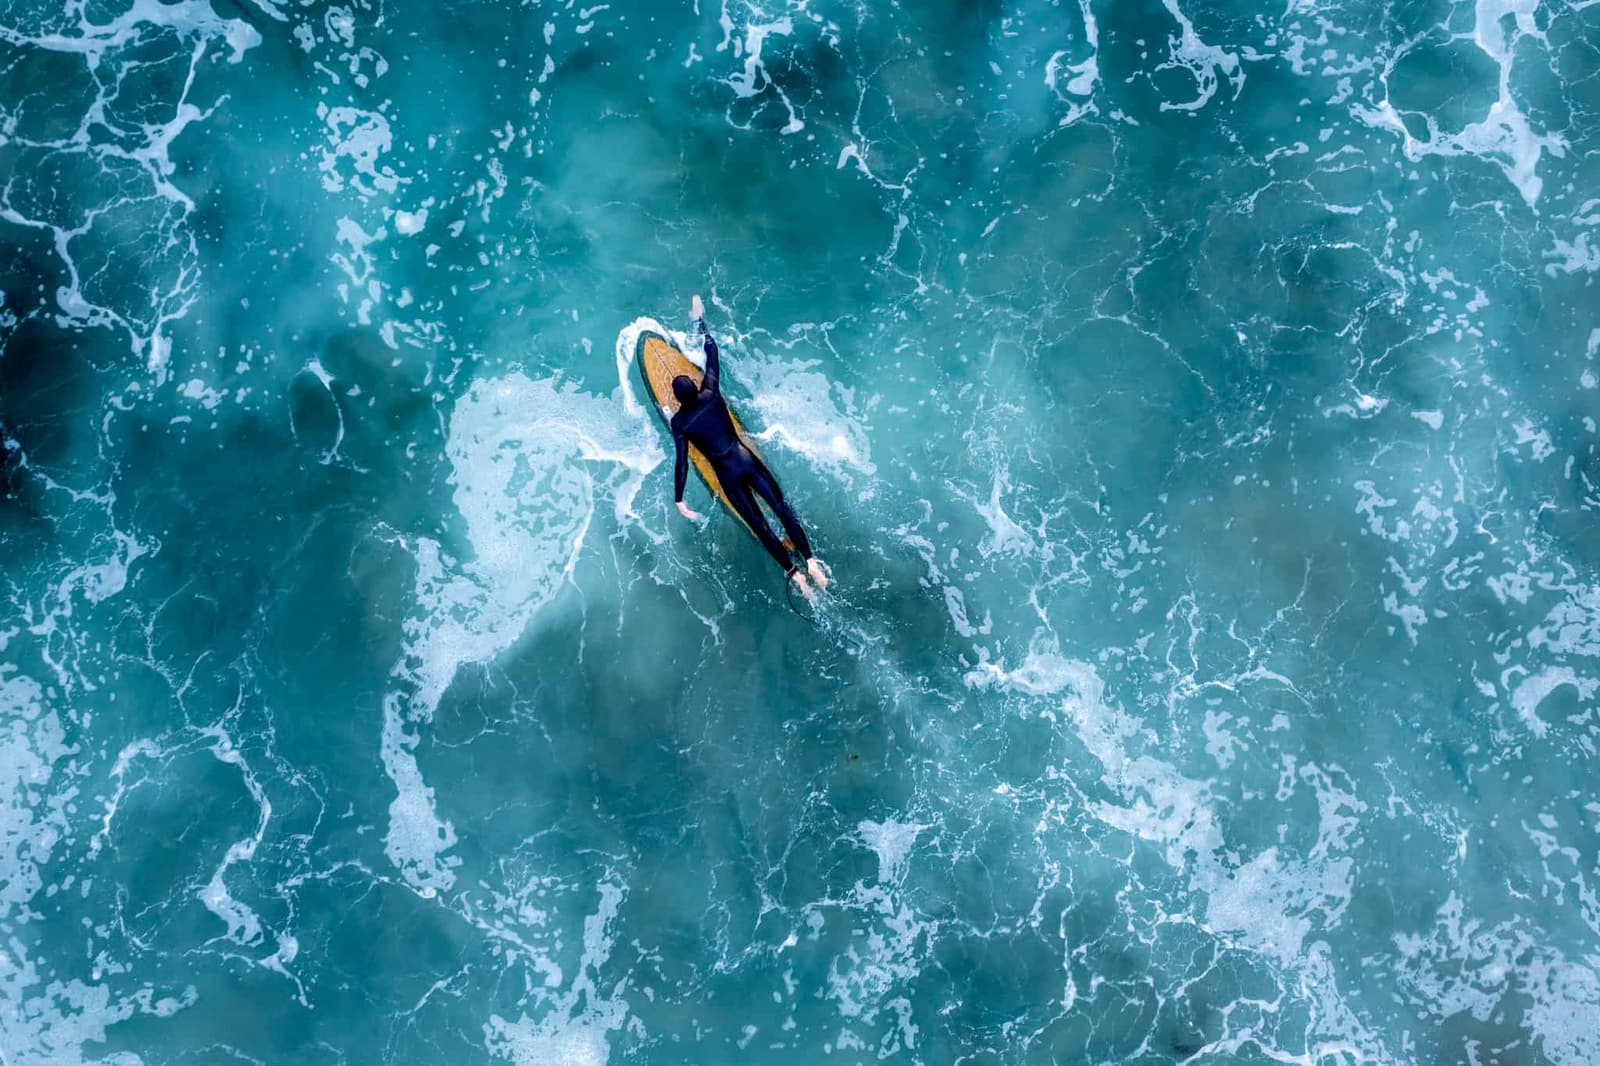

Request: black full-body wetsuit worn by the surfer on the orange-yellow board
left=672, top=319, right=811, bottom=575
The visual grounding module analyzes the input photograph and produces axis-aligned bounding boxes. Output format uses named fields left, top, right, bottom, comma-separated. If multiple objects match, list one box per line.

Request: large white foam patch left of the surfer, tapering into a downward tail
left=382, top=373, right=662, bottom=895
